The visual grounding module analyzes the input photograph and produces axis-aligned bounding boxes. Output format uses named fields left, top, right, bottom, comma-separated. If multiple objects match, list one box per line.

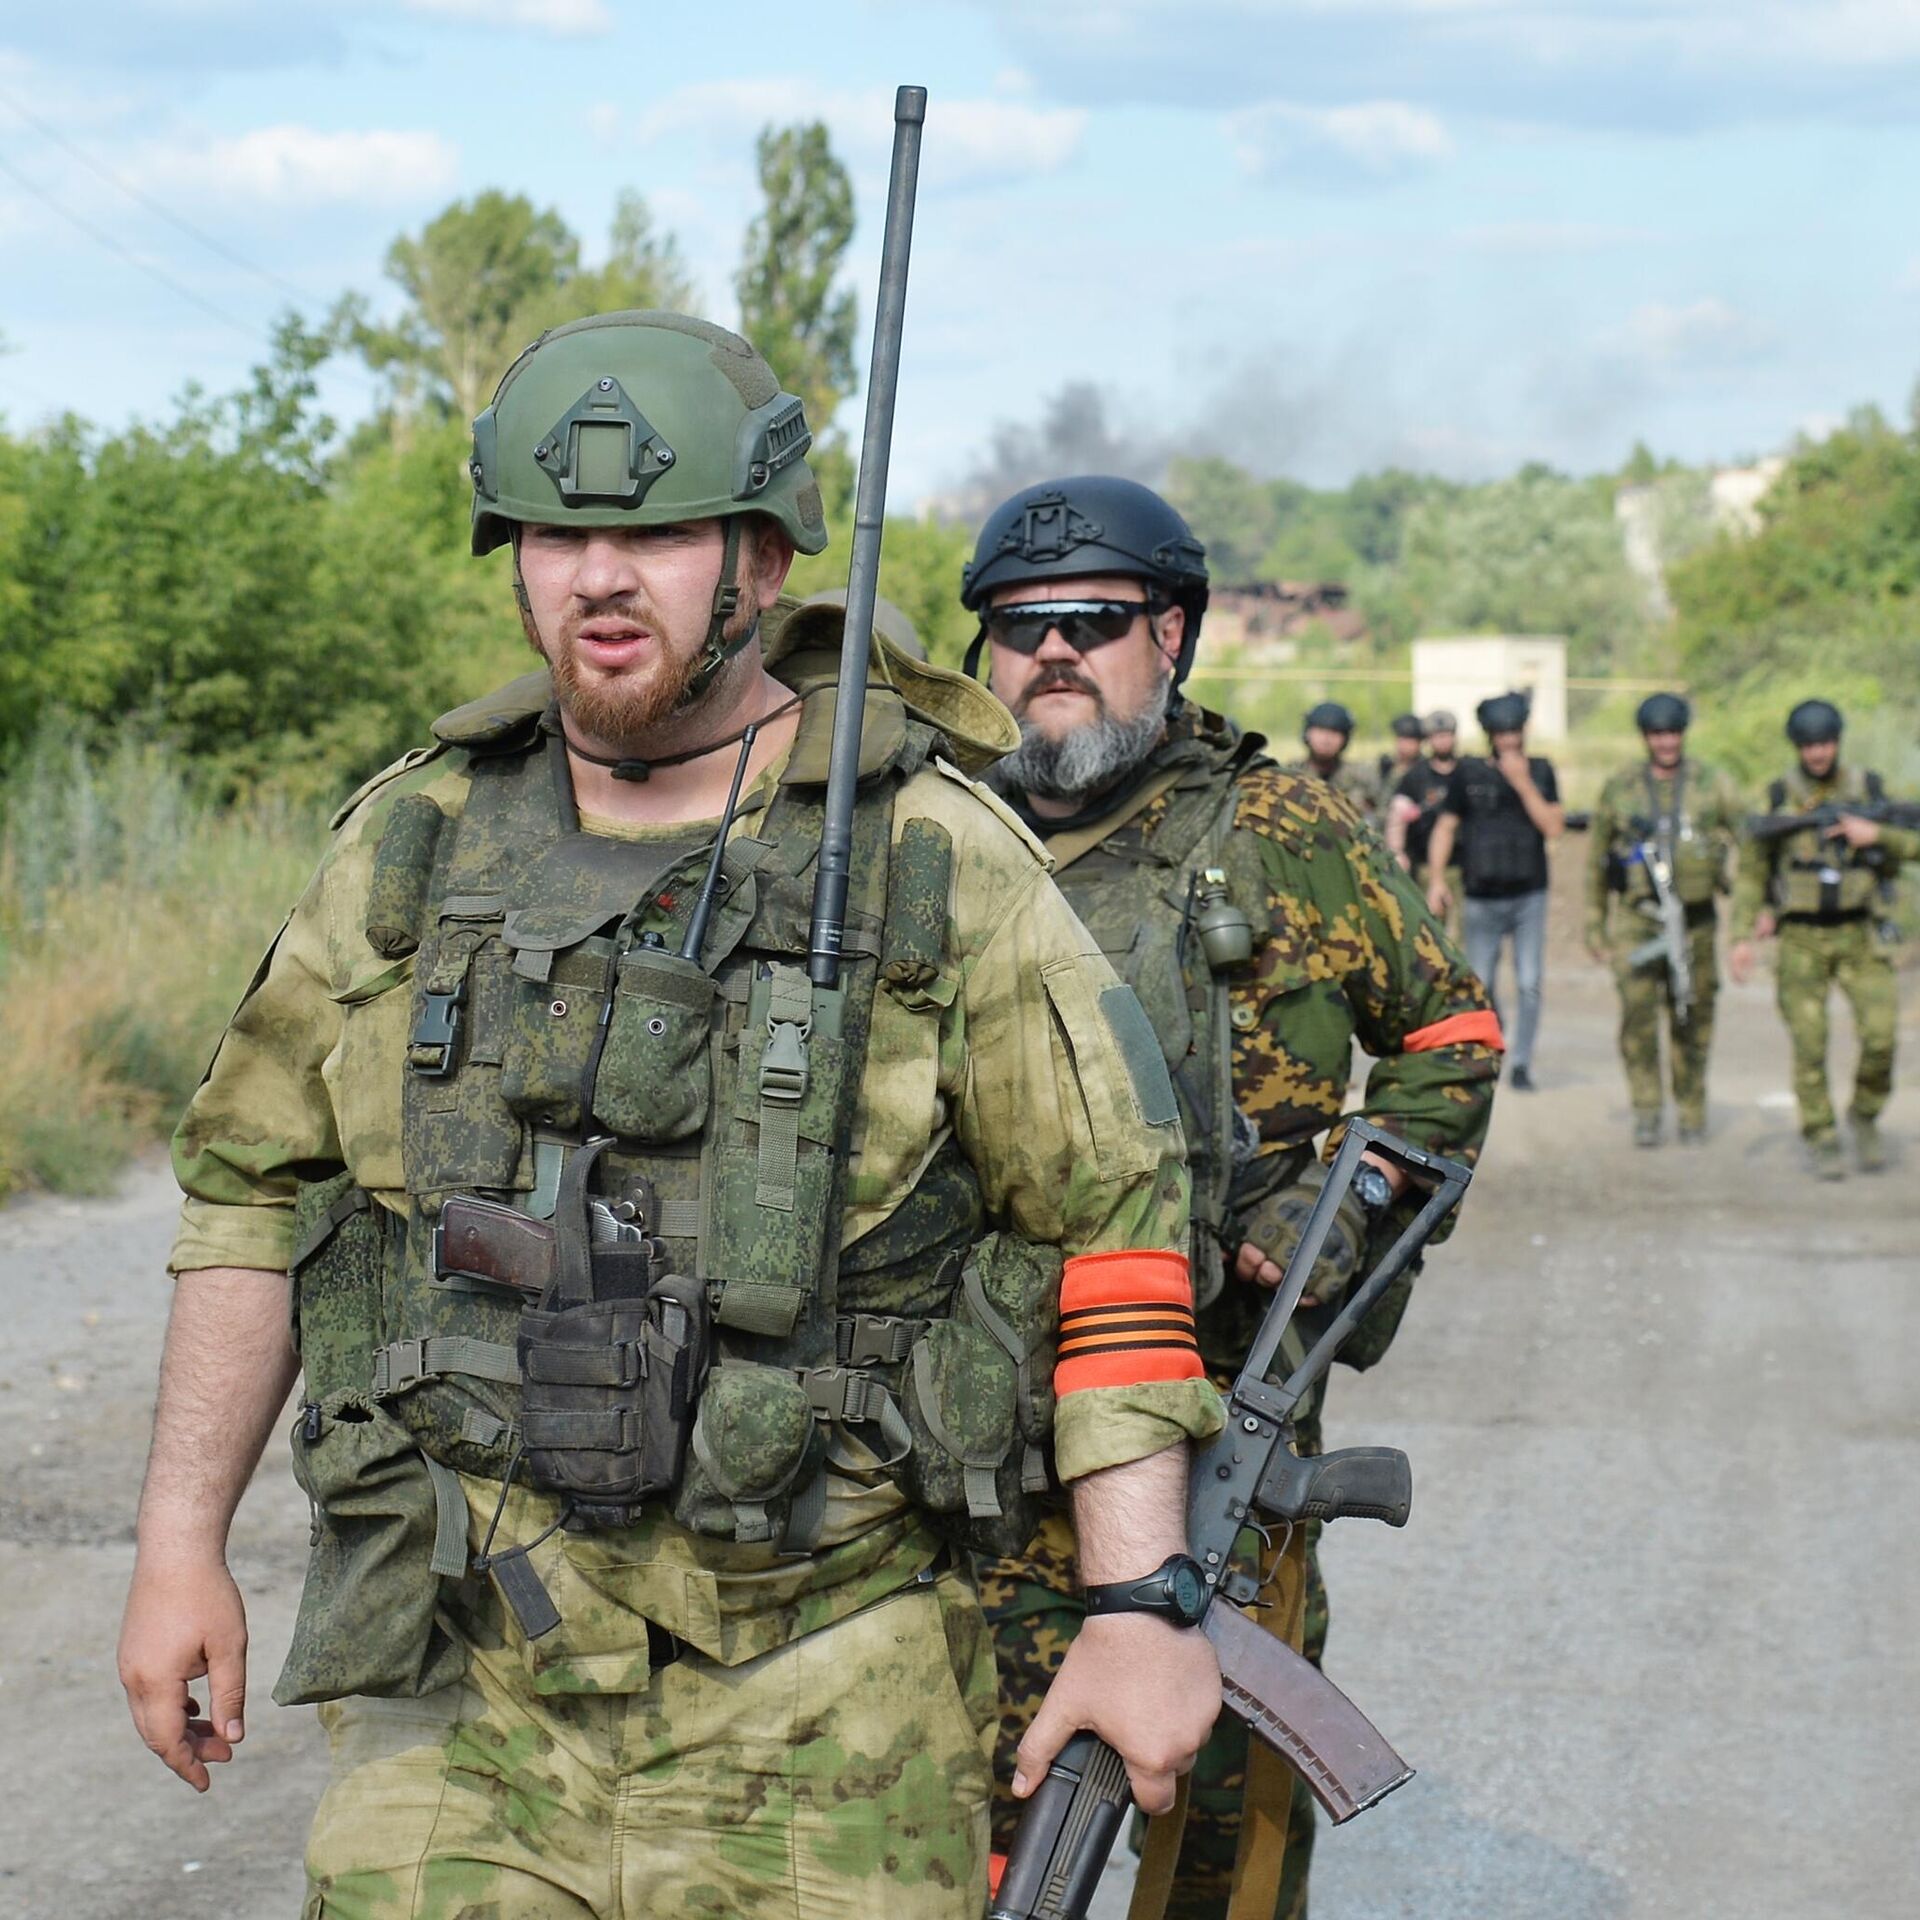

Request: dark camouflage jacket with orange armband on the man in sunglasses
left=1021, top=701, right=1500, bottom=1369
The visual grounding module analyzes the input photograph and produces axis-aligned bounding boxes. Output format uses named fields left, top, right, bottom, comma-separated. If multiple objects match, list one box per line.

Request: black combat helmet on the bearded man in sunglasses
left=960, top=474, right=1208, bottom=685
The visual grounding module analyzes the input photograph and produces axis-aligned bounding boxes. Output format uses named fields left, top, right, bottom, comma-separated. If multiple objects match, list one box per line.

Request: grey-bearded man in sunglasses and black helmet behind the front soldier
left=962, top=478, right=1500, bottom=1916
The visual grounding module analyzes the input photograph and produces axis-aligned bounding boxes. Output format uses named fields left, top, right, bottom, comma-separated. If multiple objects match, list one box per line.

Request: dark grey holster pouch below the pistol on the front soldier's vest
left=518, top=1273, right=708, bottom=1526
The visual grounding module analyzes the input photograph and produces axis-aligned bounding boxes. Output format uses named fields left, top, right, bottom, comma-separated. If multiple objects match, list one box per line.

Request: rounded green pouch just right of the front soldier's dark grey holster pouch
left=674, top=1361, right=826, bottom=1542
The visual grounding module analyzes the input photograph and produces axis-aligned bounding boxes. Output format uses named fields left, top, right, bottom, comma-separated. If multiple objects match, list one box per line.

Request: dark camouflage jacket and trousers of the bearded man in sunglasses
left=981, top=703, right=1500, bottom=1920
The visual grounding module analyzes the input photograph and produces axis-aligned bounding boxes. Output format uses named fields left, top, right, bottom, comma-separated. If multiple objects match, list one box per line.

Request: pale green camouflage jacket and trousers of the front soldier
left=171, top=616, right=1219, bottom=1920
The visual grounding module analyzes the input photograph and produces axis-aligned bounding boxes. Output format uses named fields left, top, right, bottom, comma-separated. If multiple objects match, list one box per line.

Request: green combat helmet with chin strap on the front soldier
left=467, top=311, right=828, bottom=697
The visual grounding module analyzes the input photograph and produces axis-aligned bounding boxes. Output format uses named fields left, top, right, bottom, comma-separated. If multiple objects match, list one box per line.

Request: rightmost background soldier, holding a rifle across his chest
left=1728, top=701, right=1920, bottom=1181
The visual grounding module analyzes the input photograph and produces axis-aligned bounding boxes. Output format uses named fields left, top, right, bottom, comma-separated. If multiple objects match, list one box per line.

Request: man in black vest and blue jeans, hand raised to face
left=1427, top=693, right=1567, bottom=1092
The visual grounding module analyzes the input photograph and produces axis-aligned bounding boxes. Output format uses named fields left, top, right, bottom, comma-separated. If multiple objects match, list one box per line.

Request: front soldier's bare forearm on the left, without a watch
left=138, top=1267, right=300, bottom=1555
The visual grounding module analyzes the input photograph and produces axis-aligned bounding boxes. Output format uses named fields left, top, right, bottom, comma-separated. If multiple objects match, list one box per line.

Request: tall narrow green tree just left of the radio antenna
left=733, top=121, right=856, bottom=434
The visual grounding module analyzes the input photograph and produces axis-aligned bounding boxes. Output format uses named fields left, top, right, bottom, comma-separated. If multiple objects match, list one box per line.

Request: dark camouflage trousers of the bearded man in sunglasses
left=979, top=1515, right=1327, bottom=1920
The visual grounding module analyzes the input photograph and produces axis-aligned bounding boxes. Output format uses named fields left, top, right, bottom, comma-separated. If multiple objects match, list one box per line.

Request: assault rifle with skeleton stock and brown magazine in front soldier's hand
left=989, top=1119, right=1473, bottom=1920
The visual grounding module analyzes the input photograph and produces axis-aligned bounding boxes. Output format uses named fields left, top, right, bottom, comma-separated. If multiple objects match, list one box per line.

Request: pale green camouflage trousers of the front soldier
left=305, top=1572, right=995, bottom=1920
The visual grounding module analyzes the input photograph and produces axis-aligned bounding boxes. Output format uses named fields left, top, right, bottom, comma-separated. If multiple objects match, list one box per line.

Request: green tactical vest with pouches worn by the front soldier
left=294, top=698, right=1060, bottom=1597
